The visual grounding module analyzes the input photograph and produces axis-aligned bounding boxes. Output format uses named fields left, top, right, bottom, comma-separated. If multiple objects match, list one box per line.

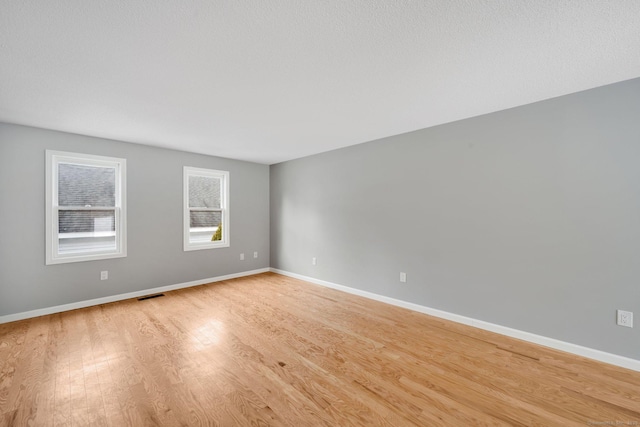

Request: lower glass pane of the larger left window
left=58, top=210, right=116, bottom=254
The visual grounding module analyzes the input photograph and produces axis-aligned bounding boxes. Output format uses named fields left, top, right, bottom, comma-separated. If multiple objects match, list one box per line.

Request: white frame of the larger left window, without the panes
left=45, top=150, right=127, bottom=265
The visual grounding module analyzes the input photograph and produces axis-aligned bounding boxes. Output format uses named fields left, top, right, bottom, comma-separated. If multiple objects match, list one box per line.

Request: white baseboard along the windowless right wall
left=270, top=268, right=640, bottom=372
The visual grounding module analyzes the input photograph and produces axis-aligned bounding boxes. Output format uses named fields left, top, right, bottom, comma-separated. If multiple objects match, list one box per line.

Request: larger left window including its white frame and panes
left=46, top=150, right=127, bottom=264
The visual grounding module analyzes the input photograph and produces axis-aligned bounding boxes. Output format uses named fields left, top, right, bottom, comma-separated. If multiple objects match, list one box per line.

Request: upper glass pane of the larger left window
left=58, top=163, right=116, bottom=206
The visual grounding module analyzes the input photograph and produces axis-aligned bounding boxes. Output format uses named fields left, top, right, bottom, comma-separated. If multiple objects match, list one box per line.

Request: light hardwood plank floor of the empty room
left=0, top=273, right=640, bottom=427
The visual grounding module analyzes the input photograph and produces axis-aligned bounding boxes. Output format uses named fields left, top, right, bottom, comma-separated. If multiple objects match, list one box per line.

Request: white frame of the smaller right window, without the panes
left=183, top=166, right=231, bottom=251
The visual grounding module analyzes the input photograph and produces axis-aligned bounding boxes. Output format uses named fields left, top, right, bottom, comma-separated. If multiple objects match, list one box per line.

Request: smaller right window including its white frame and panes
left=184, top=166, right=229, bottom=251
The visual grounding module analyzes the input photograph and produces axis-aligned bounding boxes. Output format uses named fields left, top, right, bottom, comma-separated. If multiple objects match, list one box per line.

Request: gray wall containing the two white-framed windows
left=0, top=124, right=269, bottom=315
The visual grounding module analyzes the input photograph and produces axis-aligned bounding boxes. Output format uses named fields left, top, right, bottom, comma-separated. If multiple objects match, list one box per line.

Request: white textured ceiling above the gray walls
left=0, top=0, right=640, bottom=164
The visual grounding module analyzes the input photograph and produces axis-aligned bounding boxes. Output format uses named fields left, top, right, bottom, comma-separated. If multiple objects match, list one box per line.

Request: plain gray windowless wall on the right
left=271, top=79, right=640, bottom=359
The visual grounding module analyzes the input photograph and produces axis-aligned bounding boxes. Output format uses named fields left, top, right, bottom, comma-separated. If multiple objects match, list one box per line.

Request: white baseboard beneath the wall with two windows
left=0, top=268, right=270, bottom=323
